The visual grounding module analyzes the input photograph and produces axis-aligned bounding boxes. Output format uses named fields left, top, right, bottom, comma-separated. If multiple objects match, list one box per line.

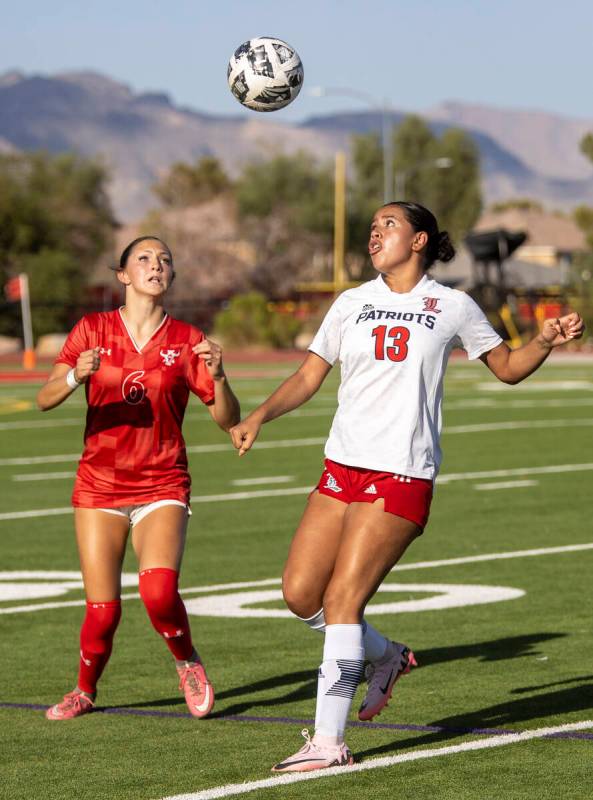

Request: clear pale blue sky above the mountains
left=0, top=0, right=593, bottom=121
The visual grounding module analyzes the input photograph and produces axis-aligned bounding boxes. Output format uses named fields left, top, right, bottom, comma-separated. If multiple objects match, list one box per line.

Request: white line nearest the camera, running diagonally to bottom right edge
left=157, top=719, right=593, bottom=800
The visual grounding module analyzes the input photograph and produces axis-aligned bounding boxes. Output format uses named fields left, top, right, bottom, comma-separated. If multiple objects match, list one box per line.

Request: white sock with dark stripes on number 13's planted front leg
left=315, top=625, right=364, bottom=745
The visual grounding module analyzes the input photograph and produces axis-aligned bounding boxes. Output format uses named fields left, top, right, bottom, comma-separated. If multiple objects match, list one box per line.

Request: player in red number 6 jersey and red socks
left=37, top=236, right=240, bottom=720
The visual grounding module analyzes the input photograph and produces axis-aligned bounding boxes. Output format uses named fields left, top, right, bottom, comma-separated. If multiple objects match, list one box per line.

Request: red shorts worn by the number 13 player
left=316, top=458, right=432, bottom=528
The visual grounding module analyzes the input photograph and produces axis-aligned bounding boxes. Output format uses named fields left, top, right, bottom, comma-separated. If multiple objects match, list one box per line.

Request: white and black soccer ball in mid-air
left=227, top=36, right=305, bottom=111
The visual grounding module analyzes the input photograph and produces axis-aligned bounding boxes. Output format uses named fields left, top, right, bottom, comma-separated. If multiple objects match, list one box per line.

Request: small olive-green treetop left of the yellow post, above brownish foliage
left=153, top=156, right=232, bottom=208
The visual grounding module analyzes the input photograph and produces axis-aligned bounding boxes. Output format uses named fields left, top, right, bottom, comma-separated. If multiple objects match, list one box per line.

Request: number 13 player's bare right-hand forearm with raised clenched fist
left=481, top=312, right=585, bottom=384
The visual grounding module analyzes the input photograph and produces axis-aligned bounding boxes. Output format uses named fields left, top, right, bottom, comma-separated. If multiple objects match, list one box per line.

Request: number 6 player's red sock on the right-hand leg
left=139, top=567, right=194, bottom=661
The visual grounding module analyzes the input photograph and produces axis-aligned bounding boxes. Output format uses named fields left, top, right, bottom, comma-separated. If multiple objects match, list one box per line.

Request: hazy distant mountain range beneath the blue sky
left=0, top=72, right=593, bottom=221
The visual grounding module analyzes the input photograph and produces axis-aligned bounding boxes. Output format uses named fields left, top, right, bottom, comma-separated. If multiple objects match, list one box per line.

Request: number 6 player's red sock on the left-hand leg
left=78, top=600, right=121, bottom=694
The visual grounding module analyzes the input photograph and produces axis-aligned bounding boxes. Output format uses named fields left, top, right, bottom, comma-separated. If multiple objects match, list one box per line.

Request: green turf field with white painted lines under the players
left=0, top=358, right=593, bottom=800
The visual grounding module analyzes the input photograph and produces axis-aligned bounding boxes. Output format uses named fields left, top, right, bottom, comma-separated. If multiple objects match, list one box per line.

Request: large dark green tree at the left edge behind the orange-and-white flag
left=0, top=153, right=114, bottom=336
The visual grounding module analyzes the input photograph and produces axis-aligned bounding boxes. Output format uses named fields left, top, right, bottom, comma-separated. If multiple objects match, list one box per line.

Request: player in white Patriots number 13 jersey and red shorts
left=231, top=202, right=583, bottom=772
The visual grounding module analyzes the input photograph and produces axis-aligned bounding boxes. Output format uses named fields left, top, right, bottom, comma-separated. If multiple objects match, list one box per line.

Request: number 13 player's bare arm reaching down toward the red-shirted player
left=230, top=353, right=331, bottom=456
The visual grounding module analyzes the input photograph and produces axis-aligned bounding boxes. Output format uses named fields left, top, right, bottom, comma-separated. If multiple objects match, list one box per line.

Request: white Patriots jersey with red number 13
left=309, top=275, right=502, bottom=479
